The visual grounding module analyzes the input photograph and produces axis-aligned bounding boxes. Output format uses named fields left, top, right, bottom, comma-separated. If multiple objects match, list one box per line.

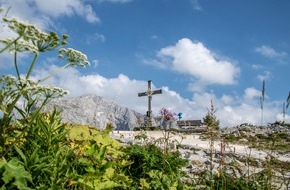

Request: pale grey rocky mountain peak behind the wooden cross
left=44, top=94, right=143, bottom=130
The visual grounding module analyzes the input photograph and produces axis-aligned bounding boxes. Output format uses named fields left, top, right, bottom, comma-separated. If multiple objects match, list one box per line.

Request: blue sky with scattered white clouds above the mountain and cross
left=0, top=0, right=290, bottom=127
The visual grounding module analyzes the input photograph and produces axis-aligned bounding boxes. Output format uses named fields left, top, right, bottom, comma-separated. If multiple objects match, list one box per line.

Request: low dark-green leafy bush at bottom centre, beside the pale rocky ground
left=123, top=144, right=188, bottom=189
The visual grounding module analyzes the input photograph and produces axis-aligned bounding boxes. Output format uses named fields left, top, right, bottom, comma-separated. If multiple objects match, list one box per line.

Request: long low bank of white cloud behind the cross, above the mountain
left=33, top=65, right=290, bottom=127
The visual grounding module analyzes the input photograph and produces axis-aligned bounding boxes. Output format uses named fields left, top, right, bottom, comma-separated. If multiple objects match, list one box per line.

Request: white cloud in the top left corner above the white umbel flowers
left=0, top=0, right=100, bottom=29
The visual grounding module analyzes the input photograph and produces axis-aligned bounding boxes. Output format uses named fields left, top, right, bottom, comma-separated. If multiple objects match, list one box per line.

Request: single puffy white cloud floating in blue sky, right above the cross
left=157, top=38, right=240, bottom=90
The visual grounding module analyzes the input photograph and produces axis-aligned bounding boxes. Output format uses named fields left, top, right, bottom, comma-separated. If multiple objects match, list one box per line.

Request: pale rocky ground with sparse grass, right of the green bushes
left=111, top=125, right=290, bottom=189
